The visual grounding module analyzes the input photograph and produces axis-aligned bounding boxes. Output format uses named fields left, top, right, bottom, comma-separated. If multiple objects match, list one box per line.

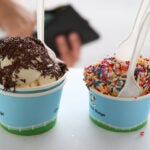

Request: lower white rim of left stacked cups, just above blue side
left=0, top=81, right=66, bottom=98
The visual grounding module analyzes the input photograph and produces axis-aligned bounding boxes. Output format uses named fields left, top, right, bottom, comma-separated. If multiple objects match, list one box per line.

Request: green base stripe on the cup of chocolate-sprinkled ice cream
left=0, top=119, right=56, bottom=136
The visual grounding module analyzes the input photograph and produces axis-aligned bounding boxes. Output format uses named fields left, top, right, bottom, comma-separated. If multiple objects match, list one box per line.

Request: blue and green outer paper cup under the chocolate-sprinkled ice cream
left=0, top=82, right=65, bottom=135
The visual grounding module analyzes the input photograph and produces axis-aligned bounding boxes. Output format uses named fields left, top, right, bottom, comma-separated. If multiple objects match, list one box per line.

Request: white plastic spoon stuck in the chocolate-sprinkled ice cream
left=37, top=0, right=56, bottom=61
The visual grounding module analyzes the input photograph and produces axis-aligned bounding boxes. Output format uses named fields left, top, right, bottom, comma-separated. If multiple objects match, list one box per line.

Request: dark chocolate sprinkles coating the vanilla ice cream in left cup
left=0, top=37, right=67, bottom=91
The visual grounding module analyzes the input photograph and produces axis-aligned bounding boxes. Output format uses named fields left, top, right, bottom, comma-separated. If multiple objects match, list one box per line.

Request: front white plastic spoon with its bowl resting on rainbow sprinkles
left=119, top=13, right=150, bottom=98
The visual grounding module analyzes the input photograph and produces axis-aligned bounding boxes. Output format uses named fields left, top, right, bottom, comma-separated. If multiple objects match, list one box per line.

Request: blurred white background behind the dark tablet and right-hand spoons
left=21, top=0, right=150, bottom=67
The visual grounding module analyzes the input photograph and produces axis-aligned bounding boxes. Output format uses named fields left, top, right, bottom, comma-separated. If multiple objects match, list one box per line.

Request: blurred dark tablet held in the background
left=34, top=5, right=100, bottom=56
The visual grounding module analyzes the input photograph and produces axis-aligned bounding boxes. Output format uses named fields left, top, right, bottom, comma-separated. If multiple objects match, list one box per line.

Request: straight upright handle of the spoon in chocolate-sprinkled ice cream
left=37, top=0, right=44, bottom=42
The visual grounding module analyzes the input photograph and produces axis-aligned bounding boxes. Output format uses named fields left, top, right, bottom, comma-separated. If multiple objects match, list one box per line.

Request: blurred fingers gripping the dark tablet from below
left=55, top=32, right=81, bottom=67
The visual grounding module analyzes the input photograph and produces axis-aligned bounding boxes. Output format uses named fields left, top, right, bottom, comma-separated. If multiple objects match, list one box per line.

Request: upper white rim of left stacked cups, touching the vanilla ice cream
left=0, top=72, right=67, bottom=92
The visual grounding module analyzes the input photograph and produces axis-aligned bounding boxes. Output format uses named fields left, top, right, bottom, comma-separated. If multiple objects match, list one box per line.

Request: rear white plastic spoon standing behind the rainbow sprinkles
left=116, top=0, right=150, bottom=61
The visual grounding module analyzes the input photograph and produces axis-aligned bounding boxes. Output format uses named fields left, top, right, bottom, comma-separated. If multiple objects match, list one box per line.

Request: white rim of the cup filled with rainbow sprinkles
left=89, top=88, right=150, bottom=101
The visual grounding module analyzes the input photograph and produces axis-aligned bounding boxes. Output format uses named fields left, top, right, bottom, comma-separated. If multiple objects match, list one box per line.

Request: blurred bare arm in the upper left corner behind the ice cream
left=0, top=0, right=36, bottom=36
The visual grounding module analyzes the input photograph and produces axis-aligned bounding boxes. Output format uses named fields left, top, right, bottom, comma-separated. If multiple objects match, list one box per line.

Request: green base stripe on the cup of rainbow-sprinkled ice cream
left=90, top=116, right=148, bottom=132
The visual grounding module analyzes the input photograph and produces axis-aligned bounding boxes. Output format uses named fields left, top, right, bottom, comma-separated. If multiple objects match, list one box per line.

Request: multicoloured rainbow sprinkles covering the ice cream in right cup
left=84, top=56, right=150, bottom=96
